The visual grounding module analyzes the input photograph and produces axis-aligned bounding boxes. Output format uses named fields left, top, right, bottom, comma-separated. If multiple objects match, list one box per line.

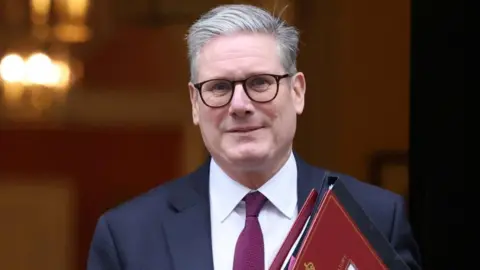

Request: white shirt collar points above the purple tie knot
left=209, top=152, right=297, bottom=222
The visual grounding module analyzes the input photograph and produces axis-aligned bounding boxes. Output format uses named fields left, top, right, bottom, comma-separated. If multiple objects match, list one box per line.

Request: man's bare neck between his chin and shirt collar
left=215, top=149, right=292, bottom=190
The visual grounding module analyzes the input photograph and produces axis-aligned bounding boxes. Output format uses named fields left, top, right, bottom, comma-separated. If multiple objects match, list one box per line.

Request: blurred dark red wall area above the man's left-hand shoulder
left=0, top=127, right=183, bottom=269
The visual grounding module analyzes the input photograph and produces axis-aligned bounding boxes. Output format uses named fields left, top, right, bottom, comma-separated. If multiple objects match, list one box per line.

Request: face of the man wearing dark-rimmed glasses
left=189, top=33, right=305, bottom=170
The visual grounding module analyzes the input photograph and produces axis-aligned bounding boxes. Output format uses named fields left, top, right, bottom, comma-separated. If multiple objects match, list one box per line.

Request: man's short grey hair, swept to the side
left=186, top=4, right=299, bottom=82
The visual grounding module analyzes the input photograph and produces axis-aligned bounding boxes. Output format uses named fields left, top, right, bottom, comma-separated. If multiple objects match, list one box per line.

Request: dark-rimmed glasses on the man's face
left=194, top=74, right=290, bottom=108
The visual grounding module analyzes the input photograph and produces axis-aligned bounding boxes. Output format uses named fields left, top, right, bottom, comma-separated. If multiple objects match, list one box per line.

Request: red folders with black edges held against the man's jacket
left=270, top=179, right=409, bottom=270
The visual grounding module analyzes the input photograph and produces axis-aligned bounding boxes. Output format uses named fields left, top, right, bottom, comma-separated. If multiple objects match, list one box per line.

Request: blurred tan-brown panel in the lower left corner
left=0, top=179, right=77, bottom=270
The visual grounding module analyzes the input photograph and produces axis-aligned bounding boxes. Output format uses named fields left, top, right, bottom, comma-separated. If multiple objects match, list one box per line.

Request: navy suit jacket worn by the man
left=87, top=156, right=420, bottom=270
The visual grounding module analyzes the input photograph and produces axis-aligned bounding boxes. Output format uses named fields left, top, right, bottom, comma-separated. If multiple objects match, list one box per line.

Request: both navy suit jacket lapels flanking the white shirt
left=164, top=153, right=327, bottom=270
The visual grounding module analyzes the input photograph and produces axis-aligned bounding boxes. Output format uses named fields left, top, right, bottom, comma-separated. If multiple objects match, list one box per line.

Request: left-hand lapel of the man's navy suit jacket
left=164, top=159, right=213, bottom=270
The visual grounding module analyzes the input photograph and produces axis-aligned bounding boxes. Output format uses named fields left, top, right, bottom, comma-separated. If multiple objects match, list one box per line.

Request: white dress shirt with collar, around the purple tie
left=209, top=153, right=298, bottom=270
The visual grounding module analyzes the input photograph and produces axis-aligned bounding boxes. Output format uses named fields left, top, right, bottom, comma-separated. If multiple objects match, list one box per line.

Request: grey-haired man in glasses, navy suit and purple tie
left=88, top=5, right=419, bottom=270
